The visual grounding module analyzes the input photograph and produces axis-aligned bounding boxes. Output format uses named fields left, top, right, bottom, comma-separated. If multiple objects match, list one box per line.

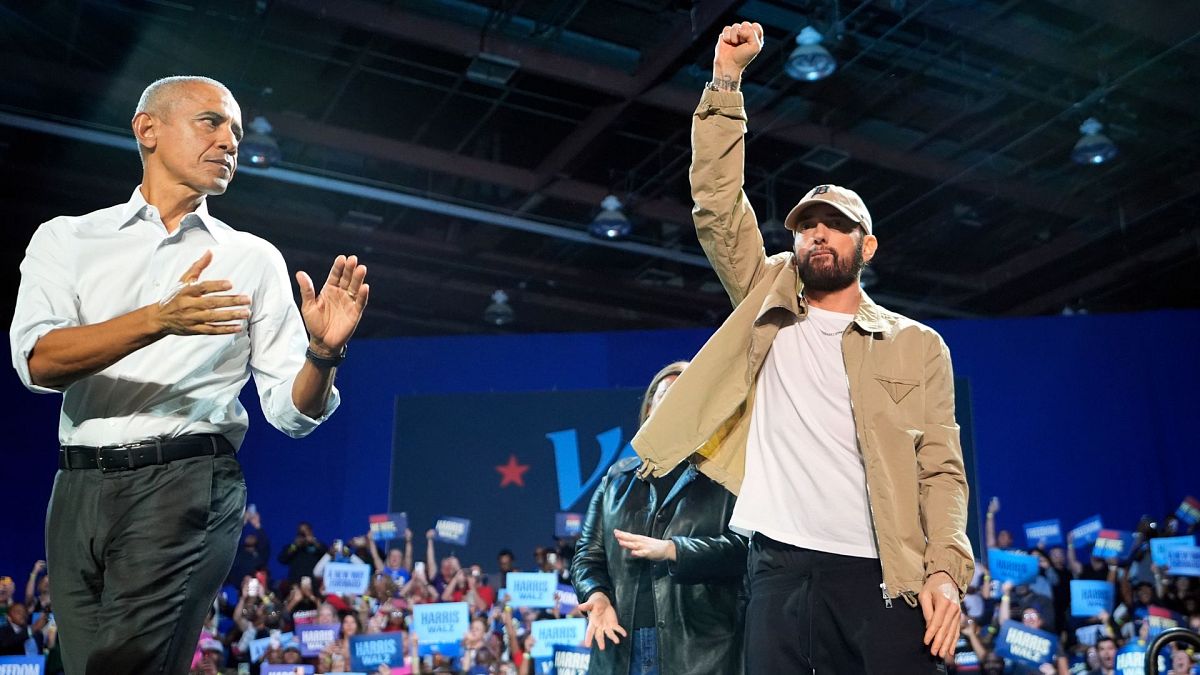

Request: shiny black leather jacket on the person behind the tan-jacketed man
left=571, top=458, right=746, bottom=675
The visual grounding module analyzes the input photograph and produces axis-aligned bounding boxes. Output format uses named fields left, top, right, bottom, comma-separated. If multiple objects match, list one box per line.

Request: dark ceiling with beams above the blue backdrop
left=0, top=0, right=1200, bottom=336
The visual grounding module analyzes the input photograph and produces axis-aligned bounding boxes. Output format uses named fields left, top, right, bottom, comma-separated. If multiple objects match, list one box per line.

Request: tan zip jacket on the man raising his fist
left=632, top=90, right=974, bottom=598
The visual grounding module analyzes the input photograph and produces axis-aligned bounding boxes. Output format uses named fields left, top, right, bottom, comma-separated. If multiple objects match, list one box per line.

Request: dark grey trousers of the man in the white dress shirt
left=46, top=449, right=246, bottom=675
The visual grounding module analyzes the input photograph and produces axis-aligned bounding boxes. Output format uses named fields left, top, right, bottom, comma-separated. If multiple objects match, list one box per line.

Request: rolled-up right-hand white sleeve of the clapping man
left=250, top=241, right=342, bottom=438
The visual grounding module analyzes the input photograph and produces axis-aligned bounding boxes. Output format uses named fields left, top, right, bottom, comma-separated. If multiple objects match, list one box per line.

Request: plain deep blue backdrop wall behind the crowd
left=0, top=311, right=1200, bottom=584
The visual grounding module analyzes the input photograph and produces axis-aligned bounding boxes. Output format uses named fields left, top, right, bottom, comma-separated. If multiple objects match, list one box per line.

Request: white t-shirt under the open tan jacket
left=730, top=305, right=880, bottom=557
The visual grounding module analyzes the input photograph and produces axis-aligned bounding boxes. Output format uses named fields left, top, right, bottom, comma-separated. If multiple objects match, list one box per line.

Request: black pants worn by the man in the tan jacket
left=744, top=534, right=946, bottom=675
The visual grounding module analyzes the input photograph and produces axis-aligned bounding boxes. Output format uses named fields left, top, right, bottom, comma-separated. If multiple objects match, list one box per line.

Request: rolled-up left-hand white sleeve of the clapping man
left=8, top=219, right=80, bottom=394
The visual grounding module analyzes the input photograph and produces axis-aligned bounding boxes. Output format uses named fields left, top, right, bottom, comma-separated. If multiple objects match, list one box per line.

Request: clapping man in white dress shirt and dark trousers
left=10, top=77, right=368, bottom=675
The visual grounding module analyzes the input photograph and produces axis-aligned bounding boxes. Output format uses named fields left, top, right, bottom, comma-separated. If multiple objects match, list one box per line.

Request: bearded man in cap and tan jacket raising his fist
left=634, top=23, right=974, bottom=675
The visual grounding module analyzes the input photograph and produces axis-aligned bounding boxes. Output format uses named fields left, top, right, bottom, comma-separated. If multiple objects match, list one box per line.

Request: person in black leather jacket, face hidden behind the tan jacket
left=571, top=362, right=746, bottom=675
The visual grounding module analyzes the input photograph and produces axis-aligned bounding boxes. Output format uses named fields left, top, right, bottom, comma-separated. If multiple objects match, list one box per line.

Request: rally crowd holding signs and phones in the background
left=0, top=501, right=1200, bottom=675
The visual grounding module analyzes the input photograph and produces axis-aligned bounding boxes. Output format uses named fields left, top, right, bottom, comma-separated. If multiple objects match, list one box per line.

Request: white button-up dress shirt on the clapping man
left=8, top=186, right=341, bottom=448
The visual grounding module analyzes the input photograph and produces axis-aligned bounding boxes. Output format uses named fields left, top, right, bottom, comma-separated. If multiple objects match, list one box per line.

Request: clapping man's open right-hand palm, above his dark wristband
left=296, top=256, right=371, bottom=354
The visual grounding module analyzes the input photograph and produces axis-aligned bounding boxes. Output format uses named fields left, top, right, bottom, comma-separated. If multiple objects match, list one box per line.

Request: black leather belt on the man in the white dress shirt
left=59, top=434, right=236, bottom=473
